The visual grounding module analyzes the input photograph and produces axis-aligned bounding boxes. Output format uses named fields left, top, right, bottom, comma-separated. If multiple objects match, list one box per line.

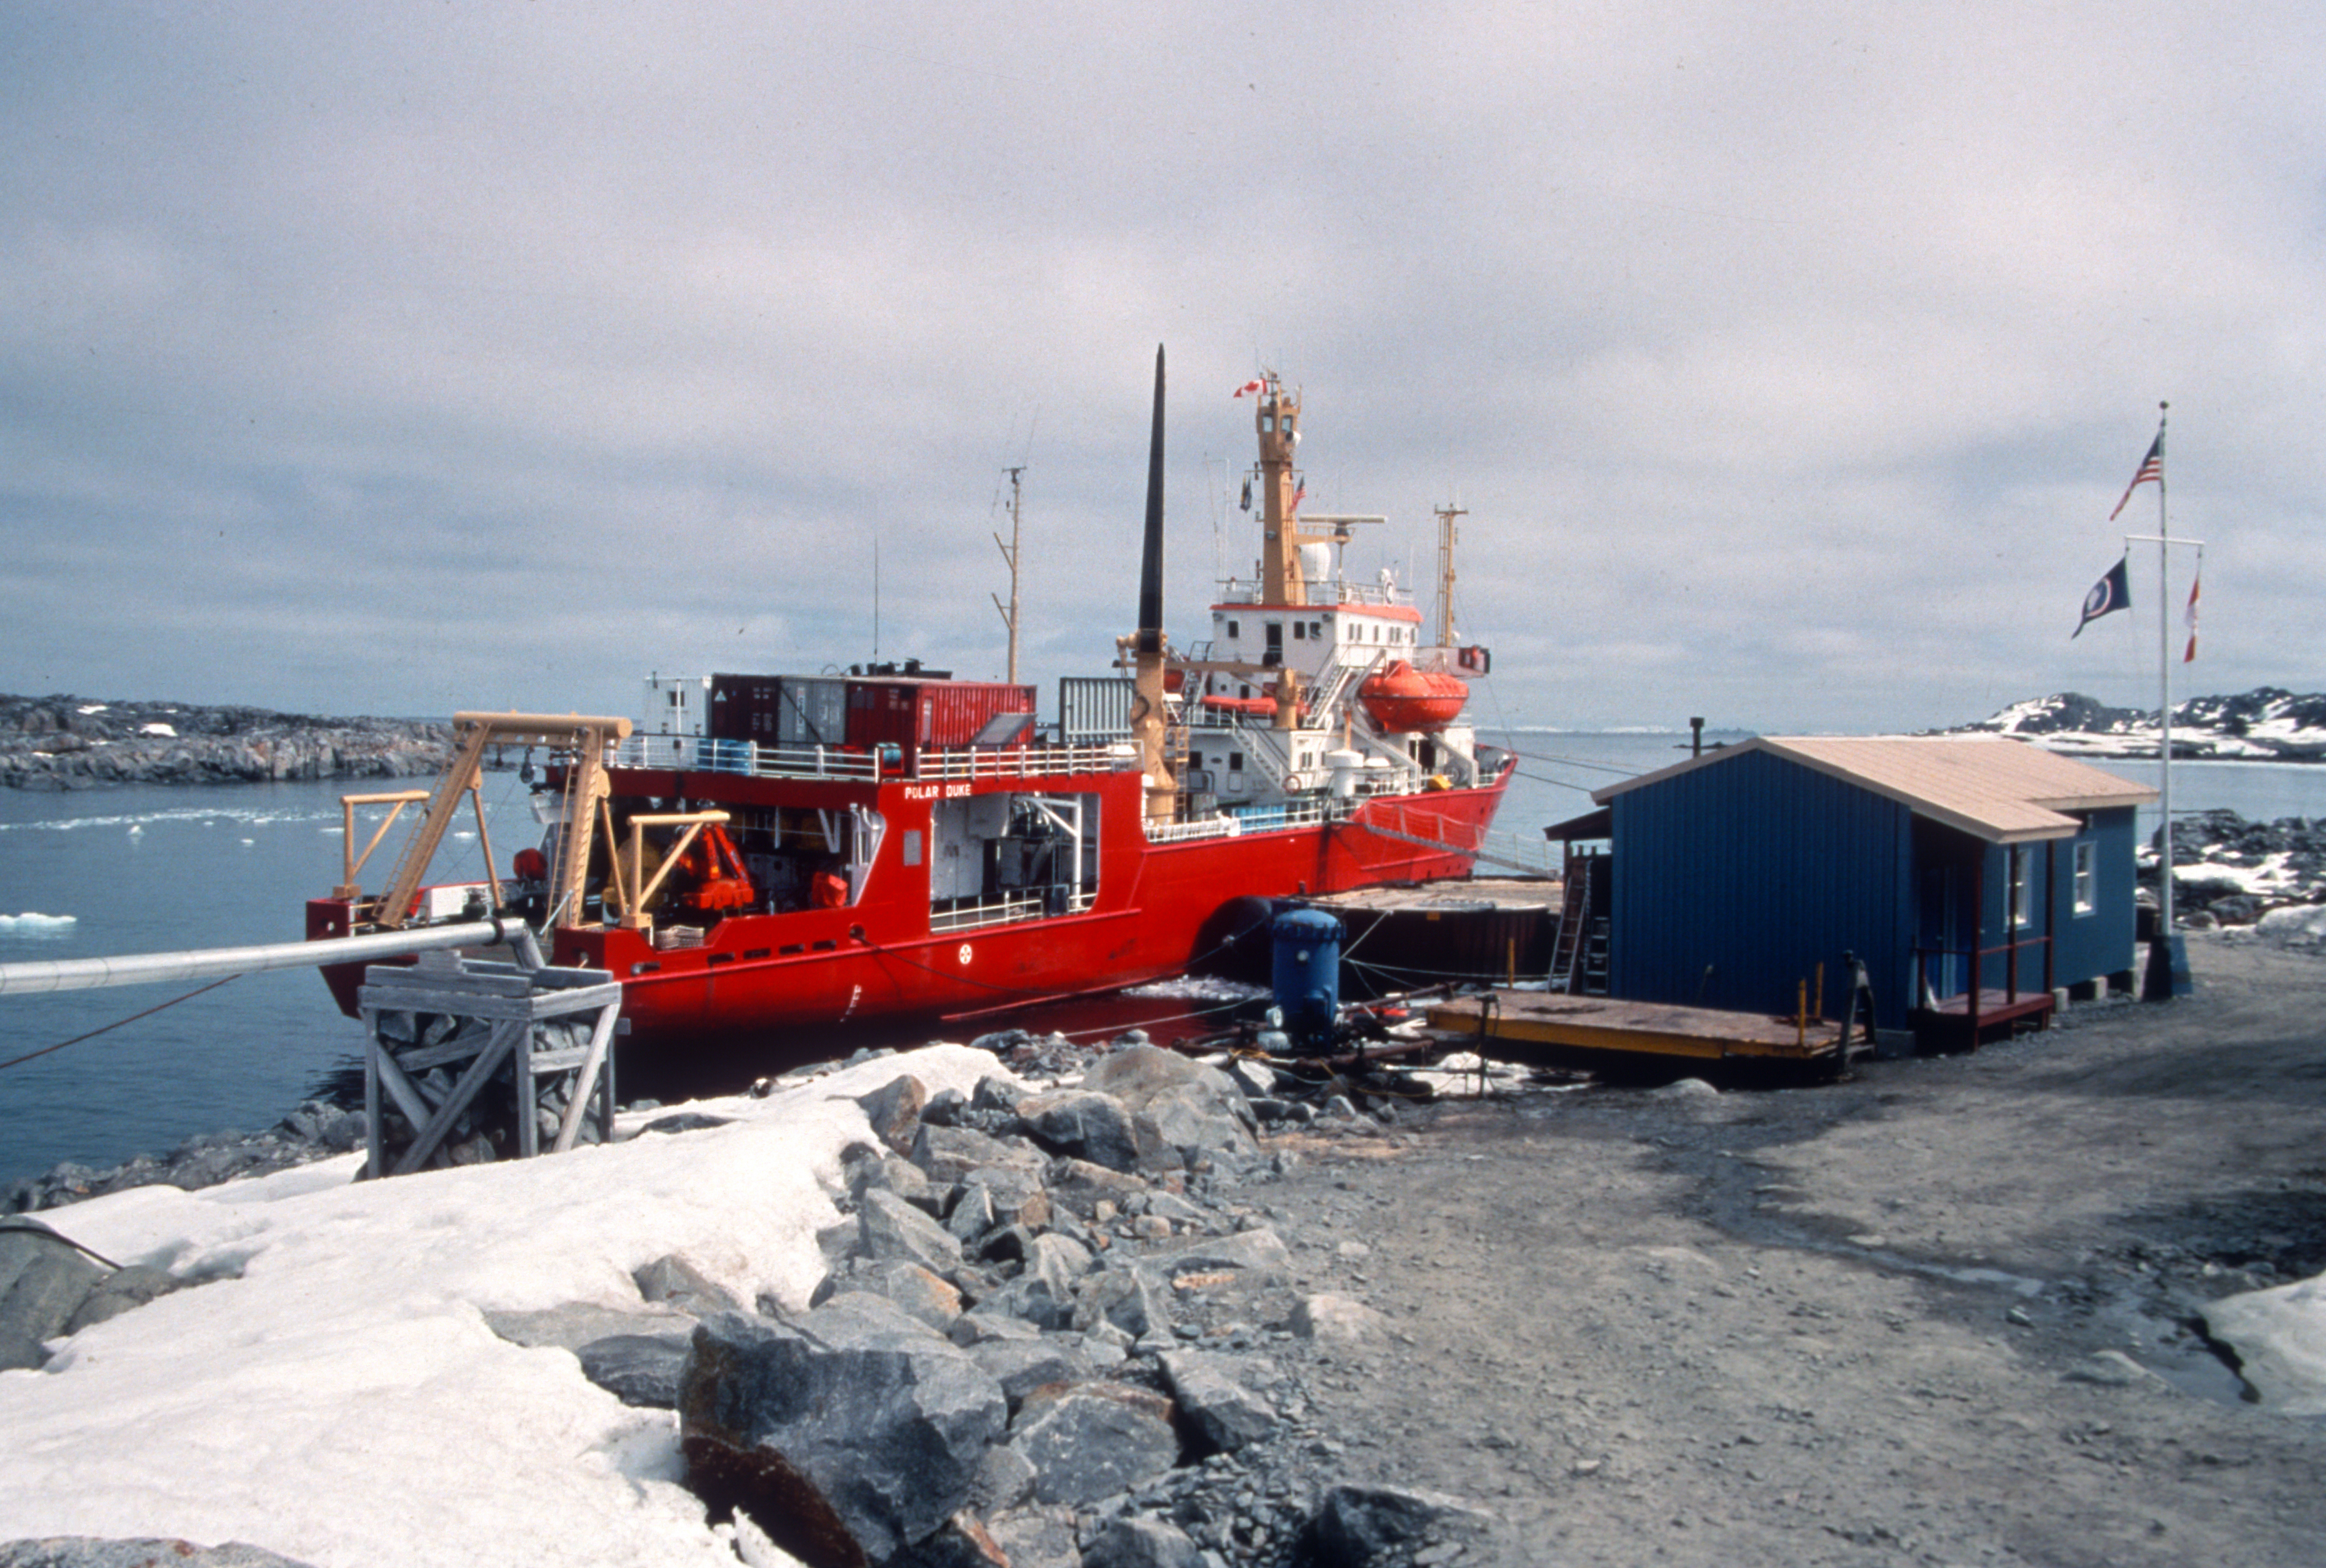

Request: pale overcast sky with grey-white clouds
left=0, top=0, right=2326, bottom=730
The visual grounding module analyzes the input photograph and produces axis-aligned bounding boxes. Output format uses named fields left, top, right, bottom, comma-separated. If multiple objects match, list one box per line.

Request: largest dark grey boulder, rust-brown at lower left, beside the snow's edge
left=679, top=1294, right=1010, bottom=1568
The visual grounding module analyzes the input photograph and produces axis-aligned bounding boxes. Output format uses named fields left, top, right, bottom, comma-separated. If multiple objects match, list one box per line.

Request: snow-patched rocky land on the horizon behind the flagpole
left=1947, top=686, right=2326, bottom=763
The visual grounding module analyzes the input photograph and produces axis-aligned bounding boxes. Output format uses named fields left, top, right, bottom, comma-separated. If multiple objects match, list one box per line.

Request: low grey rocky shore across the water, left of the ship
left=0, top=695, right=451, bottom=789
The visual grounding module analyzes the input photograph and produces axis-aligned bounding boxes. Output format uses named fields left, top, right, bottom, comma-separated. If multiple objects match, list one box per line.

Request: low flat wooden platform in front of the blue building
left=1428, top=991, right=1842, bottom=1063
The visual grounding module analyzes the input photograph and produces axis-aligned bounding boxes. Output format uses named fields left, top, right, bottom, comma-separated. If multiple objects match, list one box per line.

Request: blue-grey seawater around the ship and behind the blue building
left=0, top=730, right=2326, bottom=1180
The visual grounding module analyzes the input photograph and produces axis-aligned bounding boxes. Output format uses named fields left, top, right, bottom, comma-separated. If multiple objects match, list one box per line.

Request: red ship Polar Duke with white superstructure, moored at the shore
left=307, top=351, right=1512, bottom=1054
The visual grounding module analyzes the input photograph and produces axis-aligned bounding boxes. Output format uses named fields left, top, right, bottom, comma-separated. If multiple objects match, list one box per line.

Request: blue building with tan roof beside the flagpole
left=1581, top=735, right=2156, bottom=1040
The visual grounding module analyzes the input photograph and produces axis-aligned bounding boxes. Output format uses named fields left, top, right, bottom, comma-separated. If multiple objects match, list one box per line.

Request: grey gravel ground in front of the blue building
left=1249, top=938, right=2326, bottom=1568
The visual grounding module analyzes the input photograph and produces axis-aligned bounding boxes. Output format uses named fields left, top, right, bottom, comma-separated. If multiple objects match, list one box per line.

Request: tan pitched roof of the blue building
left=1591, top=735, right=2156, bottom=844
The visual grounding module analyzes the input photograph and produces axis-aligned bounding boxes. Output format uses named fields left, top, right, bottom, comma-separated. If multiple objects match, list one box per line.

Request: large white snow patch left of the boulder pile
left=0, top=1044, right=1010, bottom=1568
